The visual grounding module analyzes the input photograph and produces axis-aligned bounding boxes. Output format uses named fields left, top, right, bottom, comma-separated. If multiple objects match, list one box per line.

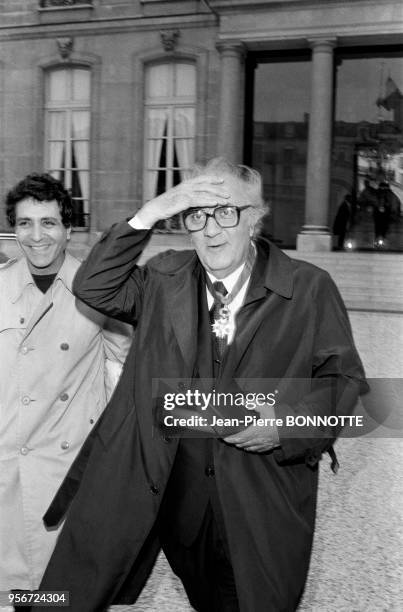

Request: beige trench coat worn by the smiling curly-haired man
left=0, top=254, right=130, bottom=590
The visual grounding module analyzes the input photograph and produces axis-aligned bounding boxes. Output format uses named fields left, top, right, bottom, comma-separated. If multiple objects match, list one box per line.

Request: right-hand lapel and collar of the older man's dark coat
left=224, top=240, right=293, bottom=373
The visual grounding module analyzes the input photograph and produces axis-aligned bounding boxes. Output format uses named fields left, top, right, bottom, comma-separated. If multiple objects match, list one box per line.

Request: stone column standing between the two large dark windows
left=297, top=39, right=336, bottom=251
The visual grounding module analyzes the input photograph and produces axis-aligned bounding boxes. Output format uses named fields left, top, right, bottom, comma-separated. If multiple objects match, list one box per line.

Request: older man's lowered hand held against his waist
left=224, top=405, right=280, bottom=453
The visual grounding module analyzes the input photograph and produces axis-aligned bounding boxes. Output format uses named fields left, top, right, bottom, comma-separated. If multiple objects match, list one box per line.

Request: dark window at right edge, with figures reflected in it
left=330, top=46, right=403, bottom=251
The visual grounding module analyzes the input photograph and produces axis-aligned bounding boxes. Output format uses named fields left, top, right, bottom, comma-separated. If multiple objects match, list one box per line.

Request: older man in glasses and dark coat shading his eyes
left=41, top=159, right=365, bottom=612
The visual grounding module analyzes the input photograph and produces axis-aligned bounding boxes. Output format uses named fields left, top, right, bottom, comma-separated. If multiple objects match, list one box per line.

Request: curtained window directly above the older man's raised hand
left=144, top=62, right=196, bottom=230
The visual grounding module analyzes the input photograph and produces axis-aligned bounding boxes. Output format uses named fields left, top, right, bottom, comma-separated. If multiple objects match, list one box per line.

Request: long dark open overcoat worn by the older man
left=41, top=223, right=365, bottom=612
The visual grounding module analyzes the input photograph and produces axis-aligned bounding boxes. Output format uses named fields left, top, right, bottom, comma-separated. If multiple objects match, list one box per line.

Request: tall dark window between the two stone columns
left=245, top=51, right=311, bottom=248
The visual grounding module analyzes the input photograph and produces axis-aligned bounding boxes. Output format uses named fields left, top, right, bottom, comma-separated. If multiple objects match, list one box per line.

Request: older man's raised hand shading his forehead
left=137, top=175, right=229, bottom=226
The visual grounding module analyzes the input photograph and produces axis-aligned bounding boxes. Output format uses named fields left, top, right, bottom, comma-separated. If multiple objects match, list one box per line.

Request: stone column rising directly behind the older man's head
left=217, top=42, right=245, bottom=164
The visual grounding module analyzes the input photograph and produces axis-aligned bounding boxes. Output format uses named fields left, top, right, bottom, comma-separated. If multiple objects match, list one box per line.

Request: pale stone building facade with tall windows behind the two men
left=0, top=0, right=403, bottom=251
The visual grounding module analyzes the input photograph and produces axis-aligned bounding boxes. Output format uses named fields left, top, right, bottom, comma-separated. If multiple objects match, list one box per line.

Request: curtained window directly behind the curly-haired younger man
left=45, top=68, right=91, bottom=228
